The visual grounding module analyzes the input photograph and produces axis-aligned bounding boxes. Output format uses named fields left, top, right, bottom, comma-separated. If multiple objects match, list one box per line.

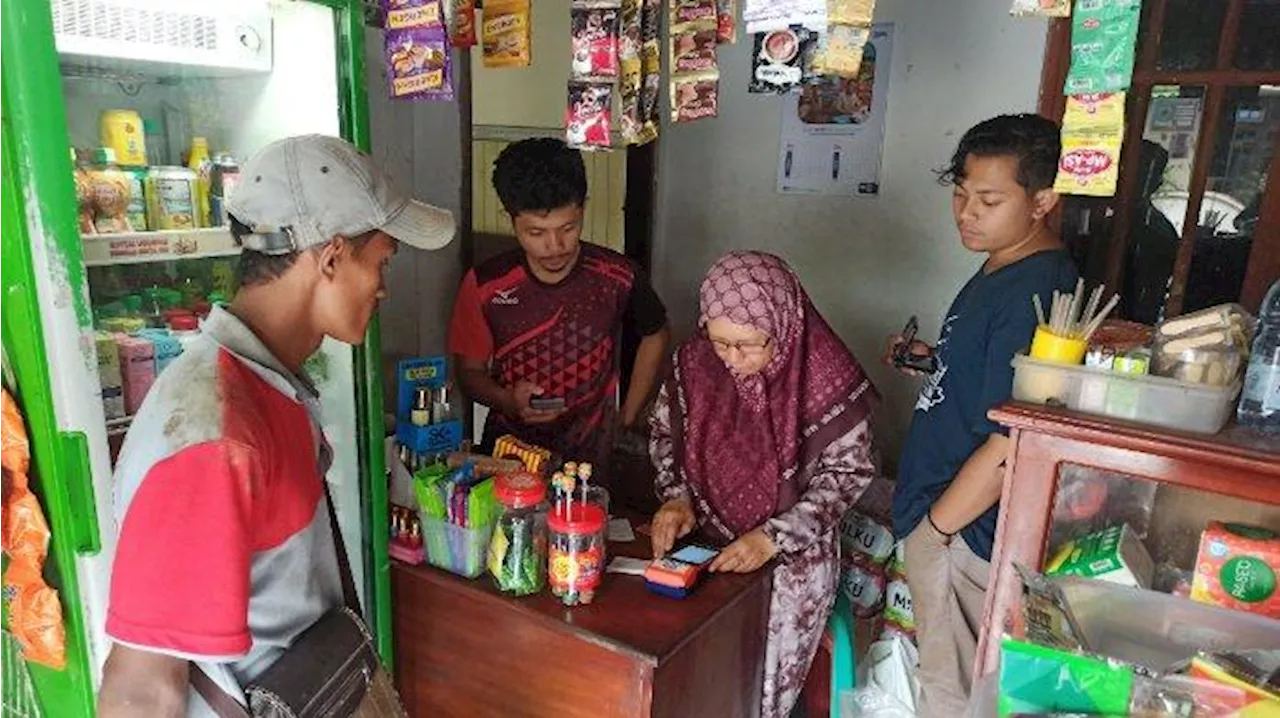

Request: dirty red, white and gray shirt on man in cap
left=106, top=308, right=343, bottom=718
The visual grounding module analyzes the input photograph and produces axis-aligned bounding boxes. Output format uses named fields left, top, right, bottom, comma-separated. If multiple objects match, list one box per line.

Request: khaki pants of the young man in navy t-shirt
left=906, top=518, right=991, bottom=718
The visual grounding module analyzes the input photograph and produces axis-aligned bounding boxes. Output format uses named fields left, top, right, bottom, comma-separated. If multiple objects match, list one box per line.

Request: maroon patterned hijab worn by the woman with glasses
left=668, top=252, right=879, bottom=539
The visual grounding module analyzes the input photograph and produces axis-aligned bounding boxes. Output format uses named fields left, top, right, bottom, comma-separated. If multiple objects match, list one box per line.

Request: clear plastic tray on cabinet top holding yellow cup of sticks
left=1012, top=355, right=1240, bottom=434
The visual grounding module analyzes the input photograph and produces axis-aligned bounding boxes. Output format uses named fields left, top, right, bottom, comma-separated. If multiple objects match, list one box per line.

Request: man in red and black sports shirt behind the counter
left=449, top=138, right=671, bottom=463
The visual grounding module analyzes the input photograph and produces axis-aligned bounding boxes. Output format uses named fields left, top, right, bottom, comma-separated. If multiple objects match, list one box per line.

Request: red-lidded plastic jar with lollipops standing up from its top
left=547, top=503, right=605, bottom=605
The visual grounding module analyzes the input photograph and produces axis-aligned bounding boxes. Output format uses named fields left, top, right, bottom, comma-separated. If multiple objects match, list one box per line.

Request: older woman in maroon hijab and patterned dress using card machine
left=649, top=252, right=878, bottom=718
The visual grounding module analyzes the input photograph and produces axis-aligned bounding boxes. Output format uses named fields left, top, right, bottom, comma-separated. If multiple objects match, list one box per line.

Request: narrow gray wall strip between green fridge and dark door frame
left=365, top=29, right=466, bottom=411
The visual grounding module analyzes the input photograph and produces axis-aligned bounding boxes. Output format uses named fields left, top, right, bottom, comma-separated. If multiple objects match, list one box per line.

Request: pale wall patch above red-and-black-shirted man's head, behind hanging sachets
left=471, top=0, right=572, bottom=129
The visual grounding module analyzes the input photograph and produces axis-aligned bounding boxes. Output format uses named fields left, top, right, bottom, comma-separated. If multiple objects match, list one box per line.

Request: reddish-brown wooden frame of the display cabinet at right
left=975, top=403, right=1280, bottom=677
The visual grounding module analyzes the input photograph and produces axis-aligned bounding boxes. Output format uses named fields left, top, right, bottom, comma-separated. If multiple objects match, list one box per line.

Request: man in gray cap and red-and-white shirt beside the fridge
left=99, top=136, right=454, bottom=718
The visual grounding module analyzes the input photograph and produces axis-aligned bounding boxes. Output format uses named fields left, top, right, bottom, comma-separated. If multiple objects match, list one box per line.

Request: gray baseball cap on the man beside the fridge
left=227, top=134, right=456, bottom=255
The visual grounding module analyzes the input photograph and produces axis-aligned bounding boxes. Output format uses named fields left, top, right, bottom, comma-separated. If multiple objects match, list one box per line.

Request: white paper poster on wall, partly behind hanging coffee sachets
left=777, top=24, right=893, bottom=197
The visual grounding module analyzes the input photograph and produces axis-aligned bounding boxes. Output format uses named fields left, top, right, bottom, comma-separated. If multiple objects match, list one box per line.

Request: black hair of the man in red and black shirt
left=493, top=137, right=586, bottom=219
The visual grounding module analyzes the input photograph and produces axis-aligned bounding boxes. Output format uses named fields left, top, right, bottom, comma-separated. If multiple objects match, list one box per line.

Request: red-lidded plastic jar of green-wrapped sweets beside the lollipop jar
left=489, top=471, right=547, bottom=596
